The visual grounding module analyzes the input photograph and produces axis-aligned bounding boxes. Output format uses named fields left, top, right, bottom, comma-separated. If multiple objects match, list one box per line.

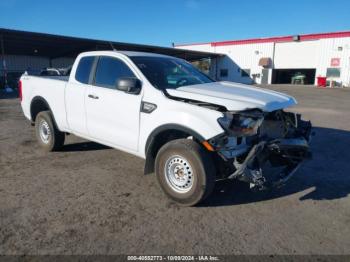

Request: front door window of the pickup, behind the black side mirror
left=94, top=56, right=135, bottom=89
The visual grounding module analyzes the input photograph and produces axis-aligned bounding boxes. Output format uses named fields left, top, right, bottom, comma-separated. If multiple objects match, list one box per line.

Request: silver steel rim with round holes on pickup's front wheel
left=164, top=155, right=194, bottom=193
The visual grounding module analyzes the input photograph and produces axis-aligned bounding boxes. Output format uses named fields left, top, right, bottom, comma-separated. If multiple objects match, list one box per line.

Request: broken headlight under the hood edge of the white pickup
left=218, top=111, right=264, bottom=136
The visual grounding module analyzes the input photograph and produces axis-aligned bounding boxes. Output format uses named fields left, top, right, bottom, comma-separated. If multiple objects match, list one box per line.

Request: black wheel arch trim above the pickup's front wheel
left=144, top=124, right=205, bottom=174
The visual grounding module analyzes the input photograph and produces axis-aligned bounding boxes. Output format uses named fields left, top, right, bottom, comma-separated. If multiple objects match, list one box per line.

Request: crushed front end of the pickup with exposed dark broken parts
left=209, top=110, right=312, bottom=190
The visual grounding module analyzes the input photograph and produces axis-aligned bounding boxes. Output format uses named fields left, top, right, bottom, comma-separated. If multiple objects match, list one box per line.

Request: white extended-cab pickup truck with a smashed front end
left=19, top=51, right=311, bottom=206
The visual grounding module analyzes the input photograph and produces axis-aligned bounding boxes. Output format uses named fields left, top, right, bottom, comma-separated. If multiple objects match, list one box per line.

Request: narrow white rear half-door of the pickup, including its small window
left=65, top=56, right=96, bottom=136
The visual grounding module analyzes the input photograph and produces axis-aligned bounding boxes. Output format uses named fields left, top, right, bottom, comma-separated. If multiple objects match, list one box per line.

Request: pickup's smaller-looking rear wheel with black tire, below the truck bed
left=35, top=111, right=65, bottom=152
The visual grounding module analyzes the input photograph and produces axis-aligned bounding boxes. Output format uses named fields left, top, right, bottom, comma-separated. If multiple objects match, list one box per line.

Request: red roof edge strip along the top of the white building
left=176, top=31, right=350, bottom=47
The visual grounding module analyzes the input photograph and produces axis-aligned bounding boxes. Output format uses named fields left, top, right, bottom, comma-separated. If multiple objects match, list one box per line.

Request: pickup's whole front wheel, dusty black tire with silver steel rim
left=155, top=139, right=216, bottom=206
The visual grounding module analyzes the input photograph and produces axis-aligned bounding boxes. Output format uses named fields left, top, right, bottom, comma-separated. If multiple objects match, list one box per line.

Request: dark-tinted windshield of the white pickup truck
left=130, top=56, right=214, bottom=90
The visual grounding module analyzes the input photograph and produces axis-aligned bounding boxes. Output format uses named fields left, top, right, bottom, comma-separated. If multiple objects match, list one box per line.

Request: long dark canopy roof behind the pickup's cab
left=0, top=28, right=220, bottom=61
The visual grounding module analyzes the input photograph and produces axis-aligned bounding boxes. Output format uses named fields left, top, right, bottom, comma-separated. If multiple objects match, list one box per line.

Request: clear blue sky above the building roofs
left=0, top=0, right=350, bottom=46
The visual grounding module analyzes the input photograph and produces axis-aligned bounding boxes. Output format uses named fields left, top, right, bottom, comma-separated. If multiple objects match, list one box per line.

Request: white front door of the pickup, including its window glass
left=85, top=56, right=142, bottom=151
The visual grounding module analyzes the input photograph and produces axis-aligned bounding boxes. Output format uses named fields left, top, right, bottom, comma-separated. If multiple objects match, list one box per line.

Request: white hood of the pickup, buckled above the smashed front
left=166, top=82, right=297, bottom=112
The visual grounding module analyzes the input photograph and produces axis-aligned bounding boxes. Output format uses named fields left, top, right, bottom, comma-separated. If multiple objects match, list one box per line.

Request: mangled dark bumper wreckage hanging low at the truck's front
left=229, top=136, right=311, bottom=190
